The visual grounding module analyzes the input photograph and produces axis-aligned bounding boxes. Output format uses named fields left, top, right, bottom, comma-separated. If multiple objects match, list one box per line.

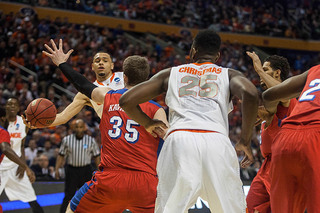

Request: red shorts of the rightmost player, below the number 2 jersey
left=270, top=125, right=320, bottom=213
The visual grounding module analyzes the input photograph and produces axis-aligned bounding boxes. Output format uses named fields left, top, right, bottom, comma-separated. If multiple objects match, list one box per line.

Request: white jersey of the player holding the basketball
left=90, top=72, right=124, bottom=118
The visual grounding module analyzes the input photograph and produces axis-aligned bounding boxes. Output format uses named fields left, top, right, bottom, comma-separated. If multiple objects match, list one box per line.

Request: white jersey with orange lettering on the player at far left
left=0, top=115, right=27, bottom=170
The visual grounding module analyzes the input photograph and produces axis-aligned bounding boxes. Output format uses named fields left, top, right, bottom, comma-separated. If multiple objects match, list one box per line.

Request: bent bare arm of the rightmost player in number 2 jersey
left=262, top=71, right=308, bottom=113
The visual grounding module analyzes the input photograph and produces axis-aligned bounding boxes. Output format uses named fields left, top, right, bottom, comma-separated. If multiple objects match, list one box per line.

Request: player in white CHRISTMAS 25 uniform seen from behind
left=119, top=30, right=258, bottom=213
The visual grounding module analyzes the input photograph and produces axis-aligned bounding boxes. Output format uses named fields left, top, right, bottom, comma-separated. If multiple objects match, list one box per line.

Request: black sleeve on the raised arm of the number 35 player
left=59, top=62, right=97, bottom=99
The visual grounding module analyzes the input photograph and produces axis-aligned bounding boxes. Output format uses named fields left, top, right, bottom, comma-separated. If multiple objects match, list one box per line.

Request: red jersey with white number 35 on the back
left=100, top=89, right=161, bottom=175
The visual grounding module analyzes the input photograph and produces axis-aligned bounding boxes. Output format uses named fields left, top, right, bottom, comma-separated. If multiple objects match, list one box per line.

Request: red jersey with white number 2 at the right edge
left=282, top=65, right=320, bottom=126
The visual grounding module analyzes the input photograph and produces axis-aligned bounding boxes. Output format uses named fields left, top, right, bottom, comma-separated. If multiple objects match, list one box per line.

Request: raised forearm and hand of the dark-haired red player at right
left=247, top=51, right=281, bottom=88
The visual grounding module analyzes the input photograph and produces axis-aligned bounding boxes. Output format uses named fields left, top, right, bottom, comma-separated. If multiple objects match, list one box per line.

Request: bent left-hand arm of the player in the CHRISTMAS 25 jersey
left=119, top=68, right=171, bottom=136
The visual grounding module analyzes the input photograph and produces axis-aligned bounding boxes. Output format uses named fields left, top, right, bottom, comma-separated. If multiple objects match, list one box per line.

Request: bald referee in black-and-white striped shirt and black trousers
left=55, top=119, right=100, bottom=213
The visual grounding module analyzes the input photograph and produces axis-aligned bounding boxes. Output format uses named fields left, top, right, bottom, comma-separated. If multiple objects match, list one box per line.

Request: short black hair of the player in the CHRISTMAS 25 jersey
left=193, top=30, right=221, bottom=55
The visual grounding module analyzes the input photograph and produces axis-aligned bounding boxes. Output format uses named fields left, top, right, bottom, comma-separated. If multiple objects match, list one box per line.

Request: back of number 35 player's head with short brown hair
left=122, top=55, right=150, bottom=86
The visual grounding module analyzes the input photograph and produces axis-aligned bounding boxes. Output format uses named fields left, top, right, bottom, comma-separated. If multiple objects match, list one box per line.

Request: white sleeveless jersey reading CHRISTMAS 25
left=166, top=62, right=232, bottom=136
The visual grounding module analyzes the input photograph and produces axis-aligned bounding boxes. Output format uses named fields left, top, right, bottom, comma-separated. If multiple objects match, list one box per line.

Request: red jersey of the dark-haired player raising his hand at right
left=260, top=98, right=297, bottom=157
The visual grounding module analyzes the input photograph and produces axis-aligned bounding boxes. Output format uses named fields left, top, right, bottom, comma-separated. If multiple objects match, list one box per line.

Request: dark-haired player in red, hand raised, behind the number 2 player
left=246, top=52, right=296, bottom=213
